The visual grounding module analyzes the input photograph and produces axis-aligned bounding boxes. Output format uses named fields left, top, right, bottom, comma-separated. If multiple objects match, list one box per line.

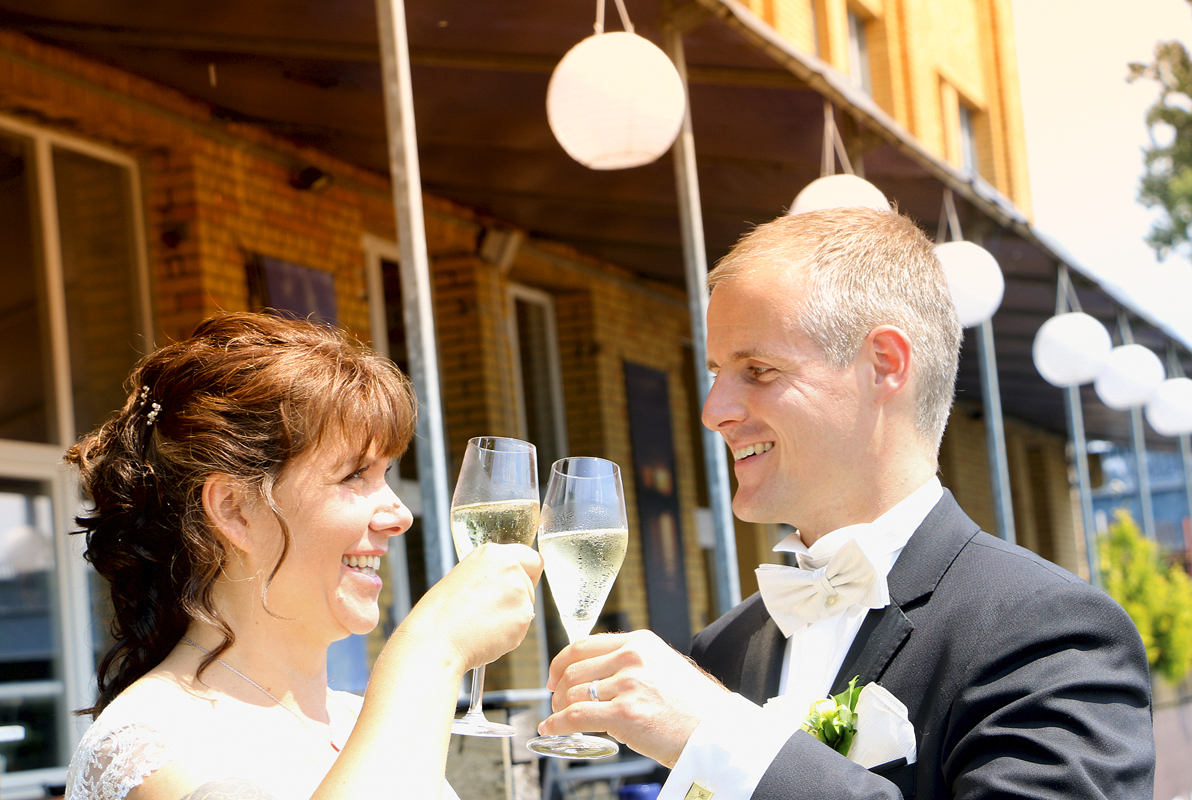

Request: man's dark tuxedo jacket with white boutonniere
left=691, top=491, right=1155, bottom=800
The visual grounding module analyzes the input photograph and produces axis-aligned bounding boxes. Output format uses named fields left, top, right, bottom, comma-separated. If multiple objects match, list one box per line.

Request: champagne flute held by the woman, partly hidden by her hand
left=451, top=436, right=539, bottom=737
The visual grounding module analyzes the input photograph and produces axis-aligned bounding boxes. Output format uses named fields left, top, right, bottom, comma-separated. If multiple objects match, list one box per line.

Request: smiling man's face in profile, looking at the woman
left=703, top=267, right=875, bottom=538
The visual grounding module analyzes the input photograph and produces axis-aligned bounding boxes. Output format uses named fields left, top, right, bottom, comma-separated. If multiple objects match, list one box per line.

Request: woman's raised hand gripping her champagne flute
left=395, top=544, right=542, bottom=675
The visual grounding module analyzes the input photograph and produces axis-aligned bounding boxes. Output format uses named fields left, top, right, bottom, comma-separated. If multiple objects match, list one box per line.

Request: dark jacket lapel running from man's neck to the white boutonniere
left=832, top=489, right=980, bottom=694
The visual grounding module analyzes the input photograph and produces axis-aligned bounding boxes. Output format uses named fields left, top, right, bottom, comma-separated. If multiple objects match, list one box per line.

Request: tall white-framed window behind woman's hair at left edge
left=0, top=119, right=151, bottom=798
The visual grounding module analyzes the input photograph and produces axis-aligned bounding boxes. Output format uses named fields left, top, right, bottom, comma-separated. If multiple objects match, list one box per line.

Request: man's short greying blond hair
left=708, top=209, right=961, bottom=449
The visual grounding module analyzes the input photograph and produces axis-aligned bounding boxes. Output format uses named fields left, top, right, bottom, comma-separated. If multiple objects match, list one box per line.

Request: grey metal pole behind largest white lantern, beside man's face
left=663, top=25, right=741, bottom=615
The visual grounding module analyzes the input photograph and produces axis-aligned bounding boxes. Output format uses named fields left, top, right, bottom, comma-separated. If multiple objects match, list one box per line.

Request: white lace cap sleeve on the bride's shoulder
left=66, top=720, right=169, bottom=800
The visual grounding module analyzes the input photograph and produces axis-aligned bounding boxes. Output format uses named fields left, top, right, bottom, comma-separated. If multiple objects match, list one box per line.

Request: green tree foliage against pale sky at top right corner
left=1128, top=14, right=1192, bottom=259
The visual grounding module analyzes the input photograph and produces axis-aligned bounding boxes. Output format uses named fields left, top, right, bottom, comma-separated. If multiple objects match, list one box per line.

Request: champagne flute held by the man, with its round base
left=527, top=457, right=629, bottom=758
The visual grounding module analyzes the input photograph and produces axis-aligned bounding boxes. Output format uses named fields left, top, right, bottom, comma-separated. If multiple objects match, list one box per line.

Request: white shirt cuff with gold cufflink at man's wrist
left=658, top=694, right=802, bottom=800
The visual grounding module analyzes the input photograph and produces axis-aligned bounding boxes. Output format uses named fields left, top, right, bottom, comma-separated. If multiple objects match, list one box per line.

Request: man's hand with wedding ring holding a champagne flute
left=538, top=631, right=728, bottom=767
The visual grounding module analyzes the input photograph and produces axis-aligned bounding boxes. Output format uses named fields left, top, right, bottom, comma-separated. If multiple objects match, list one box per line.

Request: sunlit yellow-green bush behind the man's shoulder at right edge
left=1098, top=509, right=1192, bottom=683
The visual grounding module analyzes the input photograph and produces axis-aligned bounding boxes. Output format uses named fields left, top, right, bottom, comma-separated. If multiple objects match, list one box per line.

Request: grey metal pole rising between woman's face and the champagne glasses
left=377, top=0, right=455, bottom=585
